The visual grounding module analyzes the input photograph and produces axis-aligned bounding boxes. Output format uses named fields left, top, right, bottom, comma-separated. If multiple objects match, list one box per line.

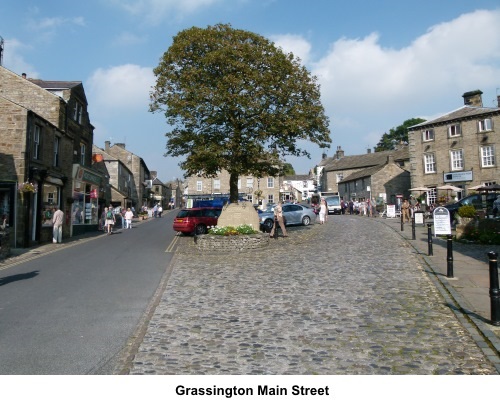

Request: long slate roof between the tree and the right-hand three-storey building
left=324, top=145, right=410, bottom=172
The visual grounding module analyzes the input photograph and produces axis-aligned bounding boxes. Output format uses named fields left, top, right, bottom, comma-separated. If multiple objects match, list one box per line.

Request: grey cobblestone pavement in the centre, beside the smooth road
left=128, top=216, right=498, bottom=375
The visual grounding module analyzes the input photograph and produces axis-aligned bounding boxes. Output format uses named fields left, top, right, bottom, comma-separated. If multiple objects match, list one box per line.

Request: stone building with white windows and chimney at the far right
left=408, top=90, right=500, bottom=204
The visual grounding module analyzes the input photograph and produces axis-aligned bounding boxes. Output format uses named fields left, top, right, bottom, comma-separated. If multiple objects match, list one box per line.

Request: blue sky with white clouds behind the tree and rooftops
left=0, top=0, right=500, bottom=182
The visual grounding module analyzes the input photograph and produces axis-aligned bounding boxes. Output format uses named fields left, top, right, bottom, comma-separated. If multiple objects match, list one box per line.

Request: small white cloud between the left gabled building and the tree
left=86, top=64, right=155, bottom=114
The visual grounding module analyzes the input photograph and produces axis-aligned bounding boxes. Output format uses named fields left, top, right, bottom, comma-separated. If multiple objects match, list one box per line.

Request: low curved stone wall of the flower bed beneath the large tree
left=194, top=233, right=269, bottom=253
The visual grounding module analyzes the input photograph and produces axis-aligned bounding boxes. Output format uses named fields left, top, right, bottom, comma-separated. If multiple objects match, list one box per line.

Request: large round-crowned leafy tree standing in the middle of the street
left=150, top=24, right=331, bottom=202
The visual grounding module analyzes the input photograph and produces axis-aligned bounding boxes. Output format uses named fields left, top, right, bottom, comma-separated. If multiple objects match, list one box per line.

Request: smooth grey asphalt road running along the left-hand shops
left=0, top=212, right=179, bottom=375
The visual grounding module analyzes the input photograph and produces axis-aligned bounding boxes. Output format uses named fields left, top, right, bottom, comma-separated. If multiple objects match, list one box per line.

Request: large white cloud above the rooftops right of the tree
left=310, top=11, right=500, bottom=154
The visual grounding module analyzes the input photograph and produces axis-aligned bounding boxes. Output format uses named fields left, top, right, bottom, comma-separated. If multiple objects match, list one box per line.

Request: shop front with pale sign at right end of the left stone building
left=71, top=165, right=103, bottom=236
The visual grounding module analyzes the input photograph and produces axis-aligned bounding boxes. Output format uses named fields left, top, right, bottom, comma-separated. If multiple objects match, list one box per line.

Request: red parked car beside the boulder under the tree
left=173, top=207, right=222, bottom=235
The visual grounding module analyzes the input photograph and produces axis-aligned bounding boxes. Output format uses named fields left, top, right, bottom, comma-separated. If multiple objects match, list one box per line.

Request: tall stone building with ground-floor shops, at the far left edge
left=0, top=66, right=103, bottom=246
